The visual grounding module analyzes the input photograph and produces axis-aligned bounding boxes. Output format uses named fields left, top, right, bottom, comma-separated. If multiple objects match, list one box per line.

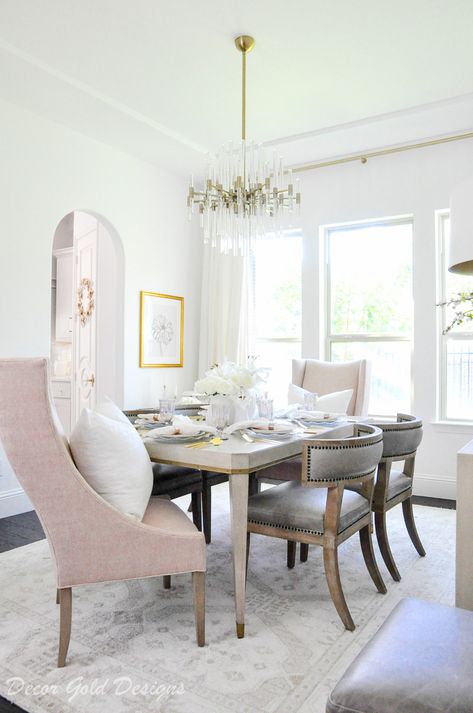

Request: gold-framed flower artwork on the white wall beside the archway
left=140, top=291, right=184, bottom=368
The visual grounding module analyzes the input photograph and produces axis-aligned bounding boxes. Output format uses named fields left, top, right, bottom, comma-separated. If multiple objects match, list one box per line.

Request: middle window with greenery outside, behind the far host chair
left=325, top=218, right=413, bottom=416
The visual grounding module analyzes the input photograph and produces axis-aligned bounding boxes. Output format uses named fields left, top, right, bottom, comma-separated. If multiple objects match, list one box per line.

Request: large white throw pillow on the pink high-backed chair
left=70, top=404, right=153, bottom=520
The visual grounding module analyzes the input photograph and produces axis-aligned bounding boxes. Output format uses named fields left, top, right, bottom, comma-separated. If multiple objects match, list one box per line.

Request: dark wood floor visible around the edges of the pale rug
left=0, top=496, right=456, bottom=713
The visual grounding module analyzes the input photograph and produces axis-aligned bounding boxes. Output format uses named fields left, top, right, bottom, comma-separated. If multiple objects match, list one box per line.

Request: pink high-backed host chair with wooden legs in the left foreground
left=0, top=359, right=205, bottom=666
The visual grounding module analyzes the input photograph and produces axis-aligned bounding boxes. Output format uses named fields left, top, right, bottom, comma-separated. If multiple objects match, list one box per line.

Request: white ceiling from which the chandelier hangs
left=0, top=0, right=473, bottom=169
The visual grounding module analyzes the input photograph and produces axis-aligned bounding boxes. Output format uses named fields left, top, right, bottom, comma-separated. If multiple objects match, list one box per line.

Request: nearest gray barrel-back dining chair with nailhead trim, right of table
left=248, top=424, right=386, bottom=631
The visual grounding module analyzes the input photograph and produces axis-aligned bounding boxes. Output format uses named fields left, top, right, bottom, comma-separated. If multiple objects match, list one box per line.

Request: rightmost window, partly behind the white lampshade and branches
left=437, top=211, right=473, bottom=421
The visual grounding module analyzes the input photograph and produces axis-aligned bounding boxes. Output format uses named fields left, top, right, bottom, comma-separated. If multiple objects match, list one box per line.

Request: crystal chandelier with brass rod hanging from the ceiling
left=187, top=35, right=301, bottom=254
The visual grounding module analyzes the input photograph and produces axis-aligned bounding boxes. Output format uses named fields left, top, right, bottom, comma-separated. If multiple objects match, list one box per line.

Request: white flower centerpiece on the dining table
left=194, top=358, right=267, bottom=423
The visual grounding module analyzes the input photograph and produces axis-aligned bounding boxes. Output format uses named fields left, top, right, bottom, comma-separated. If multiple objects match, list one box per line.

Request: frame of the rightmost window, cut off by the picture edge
left=435, top=208, right=473, bottom=425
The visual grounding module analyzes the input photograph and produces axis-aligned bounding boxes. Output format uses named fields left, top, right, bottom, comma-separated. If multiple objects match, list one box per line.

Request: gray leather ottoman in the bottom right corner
left=326, top=599, right=473, bottom=713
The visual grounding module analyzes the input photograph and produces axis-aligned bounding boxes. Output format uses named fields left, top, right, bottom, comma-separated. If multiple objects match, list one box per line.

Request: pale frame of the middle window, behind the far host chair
left=321, top=214, right=415, bottom=417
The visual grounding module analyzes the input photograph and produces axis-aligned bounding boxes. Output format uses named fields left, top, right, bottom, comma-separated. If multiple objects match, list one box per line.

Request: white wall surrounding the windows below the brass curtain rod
left=301, top=140, right=473, bottom=498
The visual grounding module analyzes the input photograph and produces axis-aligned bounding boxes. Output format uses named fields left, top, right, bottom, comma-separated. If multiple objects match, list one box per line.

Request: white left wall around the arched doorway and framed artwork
left=0, top=97, right=201, bottom=516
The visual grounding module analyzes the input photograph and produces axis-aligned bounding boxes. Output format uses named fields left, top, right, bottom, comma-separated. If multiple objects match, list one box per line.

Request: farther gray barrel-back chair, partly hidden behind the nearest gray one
left=370, top=413, right=425, bottom=582
